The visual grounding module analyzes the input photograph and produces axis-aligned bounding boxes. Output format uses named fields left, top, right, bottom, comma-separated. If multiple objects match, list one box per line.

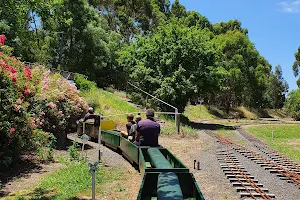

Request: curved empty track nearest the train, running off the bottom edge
left=217, top=142, right=275, bottom=199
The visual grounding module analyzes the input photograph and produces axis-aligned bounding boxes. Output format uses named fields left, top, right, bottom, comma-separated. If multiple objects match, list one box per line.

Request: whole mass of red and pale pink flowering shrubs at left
left=0, top=35, right=88, bottom=168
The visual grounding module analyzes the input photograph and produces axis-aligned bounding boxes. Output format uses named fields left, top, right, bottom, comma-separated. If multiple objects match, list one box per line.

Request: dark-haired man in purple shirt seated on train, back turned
left=135, top=109, right=160, bottom=146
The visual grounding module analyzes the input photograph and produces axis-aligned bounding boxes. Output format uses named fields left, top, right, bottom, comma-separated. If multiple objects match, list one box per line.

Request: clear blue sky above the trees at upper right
left=171, top=0, right=300, bottom=90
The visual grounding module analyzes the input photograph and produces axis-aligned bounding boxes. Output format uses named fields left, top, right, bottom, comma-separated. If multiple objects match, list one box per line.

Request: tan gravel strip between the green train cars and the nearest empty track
left=159, top=131, right=240, bottom=200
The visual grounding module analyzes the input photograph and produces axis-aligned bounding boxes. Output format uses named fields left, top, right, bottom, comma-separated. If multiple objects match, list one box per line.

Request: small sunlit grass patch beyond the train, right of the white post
left=183, top=105, right=216, bottom=121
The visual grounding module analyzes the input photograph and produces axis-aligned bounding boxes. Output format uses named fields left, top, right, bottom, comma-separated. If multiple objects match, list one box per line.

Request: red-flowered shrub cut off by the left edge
left=0, top=36, right=46, bottom=168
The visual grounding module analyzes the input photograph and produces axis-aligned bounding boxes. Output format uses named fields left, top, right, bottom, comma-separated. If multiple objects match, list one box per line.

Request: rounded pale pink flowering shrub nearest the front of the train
left=31, top=66, right=88, bottom=146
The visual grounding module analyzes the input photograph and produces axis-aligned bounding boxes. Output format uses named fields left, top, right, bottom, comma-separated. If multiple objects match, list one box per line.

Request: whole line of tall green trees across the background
left=0, top=0, right=290, bottom=111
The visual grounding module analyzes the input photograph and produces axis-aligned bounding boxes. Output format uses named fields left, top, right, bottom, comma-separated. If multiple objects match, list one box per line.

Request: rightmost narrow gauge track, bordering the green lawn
left=236, top=127, right=300, bottom=174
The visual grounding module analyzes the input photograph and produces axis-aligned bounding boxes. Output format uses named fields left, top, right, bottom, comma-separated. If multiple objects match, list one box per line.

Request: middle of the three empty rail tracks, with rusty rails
left=206, top=131, right=300, bottom=189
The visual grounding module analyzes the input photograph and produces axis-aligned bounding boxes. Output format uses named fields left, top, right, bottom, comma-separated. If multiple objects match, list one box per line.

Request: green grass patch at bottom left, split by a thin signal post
left=6, top=162, right=124, bottom=200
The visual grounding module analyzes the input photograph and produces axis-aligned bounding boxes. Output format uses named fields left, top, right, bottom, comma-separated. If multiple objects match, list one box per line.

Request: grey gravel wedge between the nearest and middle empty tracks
left=235, top=153, right=300, bottom=200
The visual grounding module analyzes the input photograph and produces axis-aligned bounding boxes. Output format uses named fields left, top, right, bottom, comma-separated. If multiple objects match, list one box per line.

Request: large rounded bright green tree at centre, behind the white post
left=119, top=20, right=214, bottom=111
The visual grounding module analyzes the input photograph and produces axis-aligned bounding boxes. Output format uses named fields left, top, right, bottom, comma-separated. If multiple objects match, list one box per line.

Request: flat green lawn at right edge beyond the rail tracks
left=247, top=125, right=300, bottom=163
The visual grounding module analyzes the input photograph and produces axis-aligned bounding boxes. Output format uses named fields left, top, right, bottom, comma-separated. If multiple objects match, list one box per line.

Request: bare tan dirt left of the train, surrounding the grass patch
left=0, top=135, right=142, bottom=200
